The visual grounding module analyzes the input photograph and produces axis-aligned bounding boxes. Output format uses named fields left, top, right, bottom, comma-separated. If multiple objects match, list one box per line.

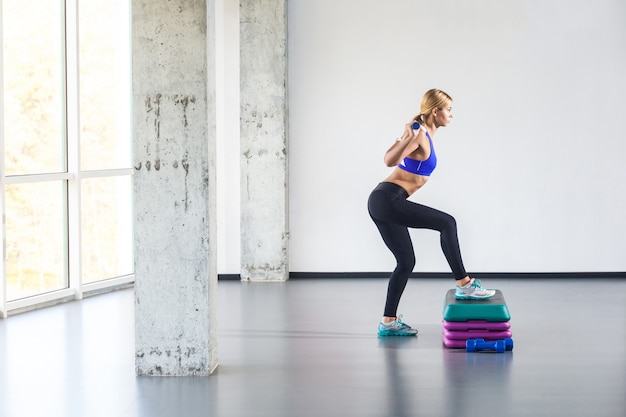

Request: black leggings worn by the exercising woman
left=367, top=182, right=467, bottom=317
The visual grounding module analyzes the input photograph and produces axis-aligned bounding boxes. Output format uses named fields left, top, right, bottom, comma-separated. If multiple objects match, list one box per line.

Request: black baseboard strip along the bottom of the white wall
left=218, top=272, right=626, bottom=281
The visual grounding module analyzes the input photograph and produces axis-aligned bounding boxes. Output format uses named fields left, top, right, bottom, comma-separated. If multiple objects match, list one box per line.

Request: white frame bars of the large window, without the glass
left=0, top=0, right=135, bottom=318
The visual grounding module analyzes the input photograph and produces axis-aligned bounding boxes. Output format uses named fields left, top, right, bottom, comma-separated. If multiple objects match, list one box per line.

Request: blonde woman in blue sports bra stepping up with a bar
left=368, top=89, right=495, bottom=336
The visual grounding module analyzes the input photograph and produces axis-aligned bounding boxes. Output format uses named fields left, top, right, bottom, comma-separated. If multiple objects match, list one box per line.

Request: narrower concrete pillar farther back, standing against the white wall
left=239, top=0, right=289, bottom=281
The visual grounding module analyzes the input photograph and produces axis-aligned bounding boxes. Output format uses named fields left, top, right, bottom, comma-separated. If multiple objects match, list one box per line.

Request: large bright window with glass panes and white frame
left=0, top=0, right=134, bottom=316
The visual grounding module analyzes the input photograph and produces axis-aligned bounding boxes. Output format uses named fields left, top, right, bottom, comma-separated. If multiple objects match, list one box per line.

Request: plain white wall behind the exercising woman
left=218, top=0, right=626, bottom=273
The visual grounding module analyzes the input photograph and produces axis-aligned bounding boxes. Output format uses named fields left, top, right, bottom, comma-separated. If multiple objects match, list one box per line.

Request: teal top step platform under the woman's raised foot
left=443, top=289, right=511, bottom=322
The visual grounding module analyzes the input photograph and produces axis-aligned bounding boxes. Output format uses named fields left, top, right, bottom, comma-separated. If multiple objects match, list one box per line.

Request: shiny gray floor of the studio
left=0, top=279, right=626, bottom=417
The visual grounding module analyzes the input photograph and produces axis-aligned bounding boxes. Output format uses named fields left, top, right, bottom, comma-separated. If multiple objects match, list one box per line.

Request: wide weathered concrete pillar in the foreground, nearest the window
left=132, top=0, right=217, bottom=376
